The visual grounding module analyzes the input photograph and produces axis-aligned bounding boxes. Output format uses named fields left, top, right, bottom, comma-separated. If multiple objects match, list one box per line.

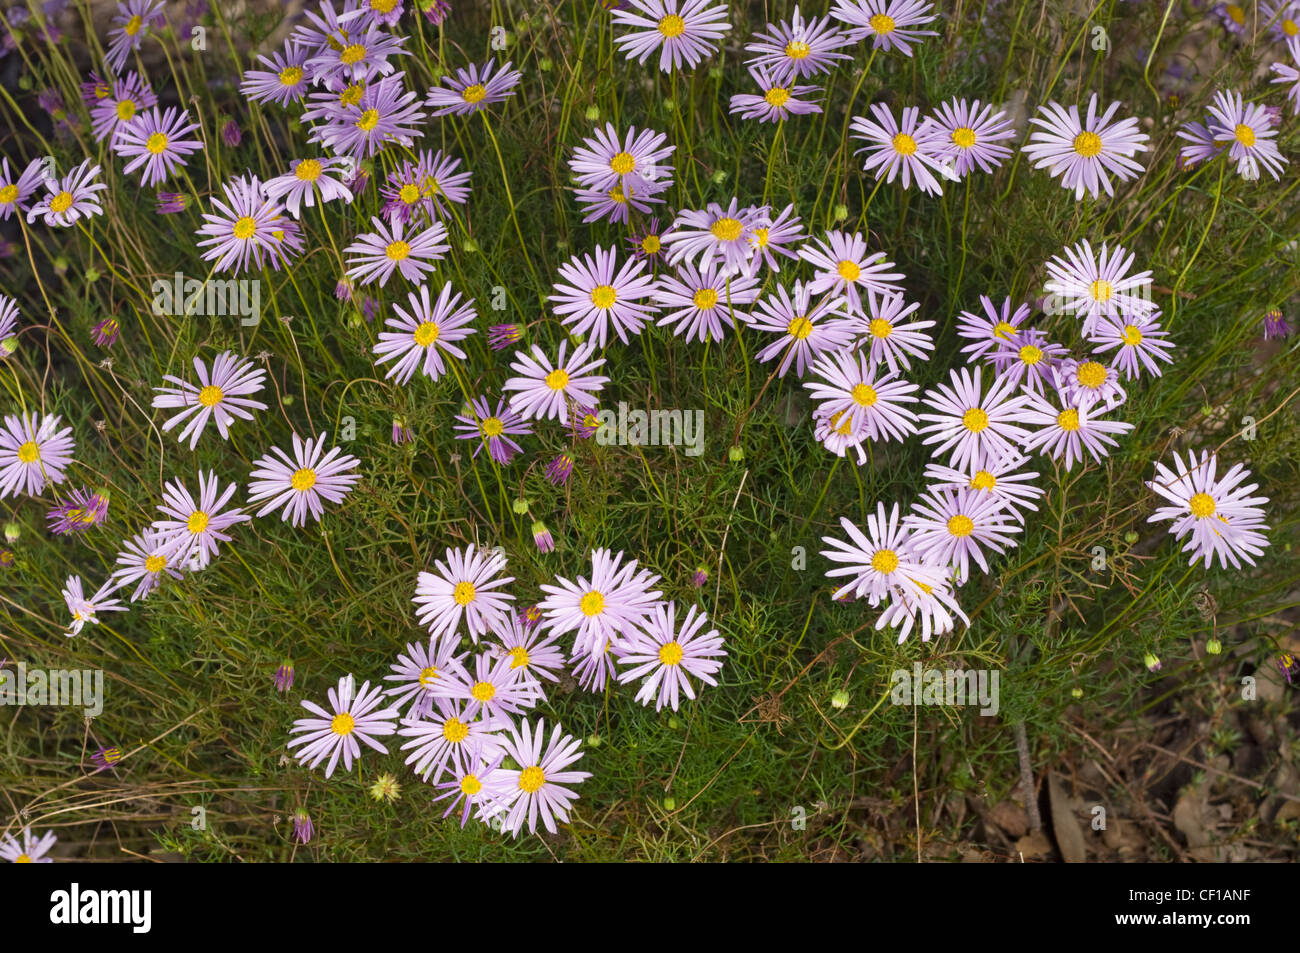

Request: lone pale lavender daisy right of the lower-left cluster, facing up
left=248, top=433, right=361, bottom=528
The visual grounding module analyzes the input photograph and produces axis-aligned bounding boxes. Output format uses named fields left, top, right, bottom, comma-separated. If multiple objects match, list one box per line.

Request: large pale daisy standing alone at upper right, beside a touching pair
left=1023, top=94, right=1151, bottom=200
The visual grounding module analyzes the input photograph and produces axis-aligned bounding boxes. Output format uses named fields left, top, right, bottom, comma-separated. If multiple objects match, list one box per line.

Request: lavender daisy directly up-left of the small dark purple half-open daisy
left=373, top=278, right=478, bottom=384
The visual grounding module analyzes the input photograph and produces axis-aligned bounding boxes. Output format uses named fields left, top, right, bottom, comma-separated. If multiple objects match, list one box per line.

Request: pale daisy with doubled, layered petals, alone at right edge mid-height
left=1147, top=450, right=1269, bottom=569
